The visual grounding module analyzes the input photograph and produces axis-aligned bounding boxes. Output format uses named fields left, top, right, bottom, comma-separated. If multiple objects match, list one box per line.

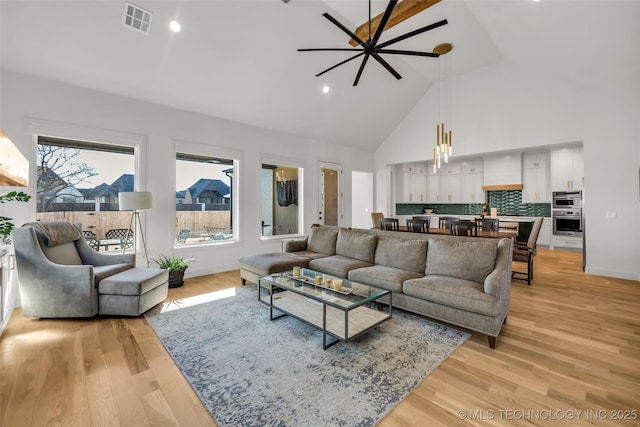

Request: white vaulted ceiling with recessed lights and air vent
left=0, top=0, right=640, bottom=150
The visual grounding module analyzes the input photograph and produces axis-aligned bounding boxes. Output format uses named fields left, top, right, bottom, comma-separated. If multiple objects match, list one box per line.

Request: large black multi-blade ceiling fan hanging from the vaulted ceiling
left=298, top=0, right=447, bottom=86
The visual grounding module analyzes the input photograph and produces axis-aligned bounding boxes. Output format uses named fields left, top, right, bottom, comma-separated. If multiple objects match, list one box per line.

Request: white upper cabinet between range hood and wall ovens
left=522, top=152, right=551, bottom=203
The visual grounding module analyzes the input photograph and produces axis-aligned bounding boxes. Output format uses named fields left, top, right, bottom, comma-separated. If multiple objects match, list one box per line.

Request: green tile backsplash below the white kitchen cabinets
left=396, top=190, right=551, bottom=217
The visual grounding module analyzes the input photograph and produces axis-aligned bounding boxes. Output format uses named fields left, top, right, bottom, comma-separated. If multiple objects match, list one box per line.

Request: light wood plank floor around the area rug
left=0, top=250, right=640, bottom=427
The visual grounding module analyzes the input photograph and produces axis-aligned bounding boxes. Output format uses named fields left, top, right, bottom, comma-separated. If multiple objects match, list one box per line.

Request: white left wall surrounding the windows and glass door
left=0, top=70, right=373, bottom=314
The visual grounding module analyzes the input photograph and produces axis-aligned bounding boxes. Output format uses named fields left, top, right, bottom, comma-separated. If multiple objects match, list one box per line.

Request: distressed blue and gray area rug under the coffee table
left=146, top=285, right=469, bottom=427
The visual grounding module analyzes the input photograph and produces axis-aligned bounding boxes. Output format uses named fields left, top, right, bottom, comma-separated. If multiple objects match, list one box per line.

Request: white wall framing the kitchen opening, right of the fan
left=375, top=63, right=640, bottom=280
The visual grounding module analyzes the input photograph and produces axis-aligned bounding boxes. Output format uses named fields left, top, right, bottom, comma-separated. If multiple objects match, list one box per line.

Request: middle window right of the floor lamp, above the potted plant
left=176, top=152, right=237, bottom=246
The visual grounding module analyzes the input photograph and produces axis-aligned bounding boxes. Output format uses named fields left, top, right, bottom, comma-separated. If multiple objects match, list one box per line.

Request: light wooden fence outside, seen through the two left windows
left=37, top=211, right=231, bottom=239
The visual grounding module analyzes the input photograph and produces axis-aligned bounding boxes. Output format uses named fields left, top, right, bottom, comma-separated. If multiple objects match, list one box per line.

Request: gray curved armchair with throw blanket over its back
left=13, top=221, right=134, bottom=318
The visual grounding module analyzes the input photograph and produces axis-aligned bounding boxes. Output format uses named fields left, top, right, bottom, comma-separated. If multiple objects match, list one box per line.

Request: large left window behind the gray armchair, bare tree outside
left=36, top=136, right=135, bottom=250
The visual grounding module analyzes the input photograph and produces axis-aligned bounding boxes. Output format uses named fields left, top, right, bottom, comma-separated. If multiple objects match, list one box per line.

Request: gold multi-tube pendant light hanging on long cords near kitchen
left=433, top=43, right=453, bottom=173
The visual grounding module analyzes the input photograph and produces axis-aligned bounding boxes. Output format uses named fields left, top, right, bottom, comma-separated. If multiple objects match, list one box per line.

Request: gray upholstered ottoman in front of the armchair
left=98, top=268, right=169, bottom=316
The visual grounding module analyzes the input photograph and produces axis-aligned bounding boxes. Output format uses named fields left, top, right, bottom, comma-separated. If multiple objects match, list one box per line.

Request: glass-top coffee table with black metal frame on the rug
left=258, top=268, right=392, bottom=349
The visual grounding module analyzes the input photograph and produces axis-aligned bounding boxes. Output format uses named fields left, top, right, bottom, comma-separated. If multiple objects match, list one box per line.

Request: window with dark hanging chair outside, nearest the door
left=261, top=162, right=303, bottom=238
